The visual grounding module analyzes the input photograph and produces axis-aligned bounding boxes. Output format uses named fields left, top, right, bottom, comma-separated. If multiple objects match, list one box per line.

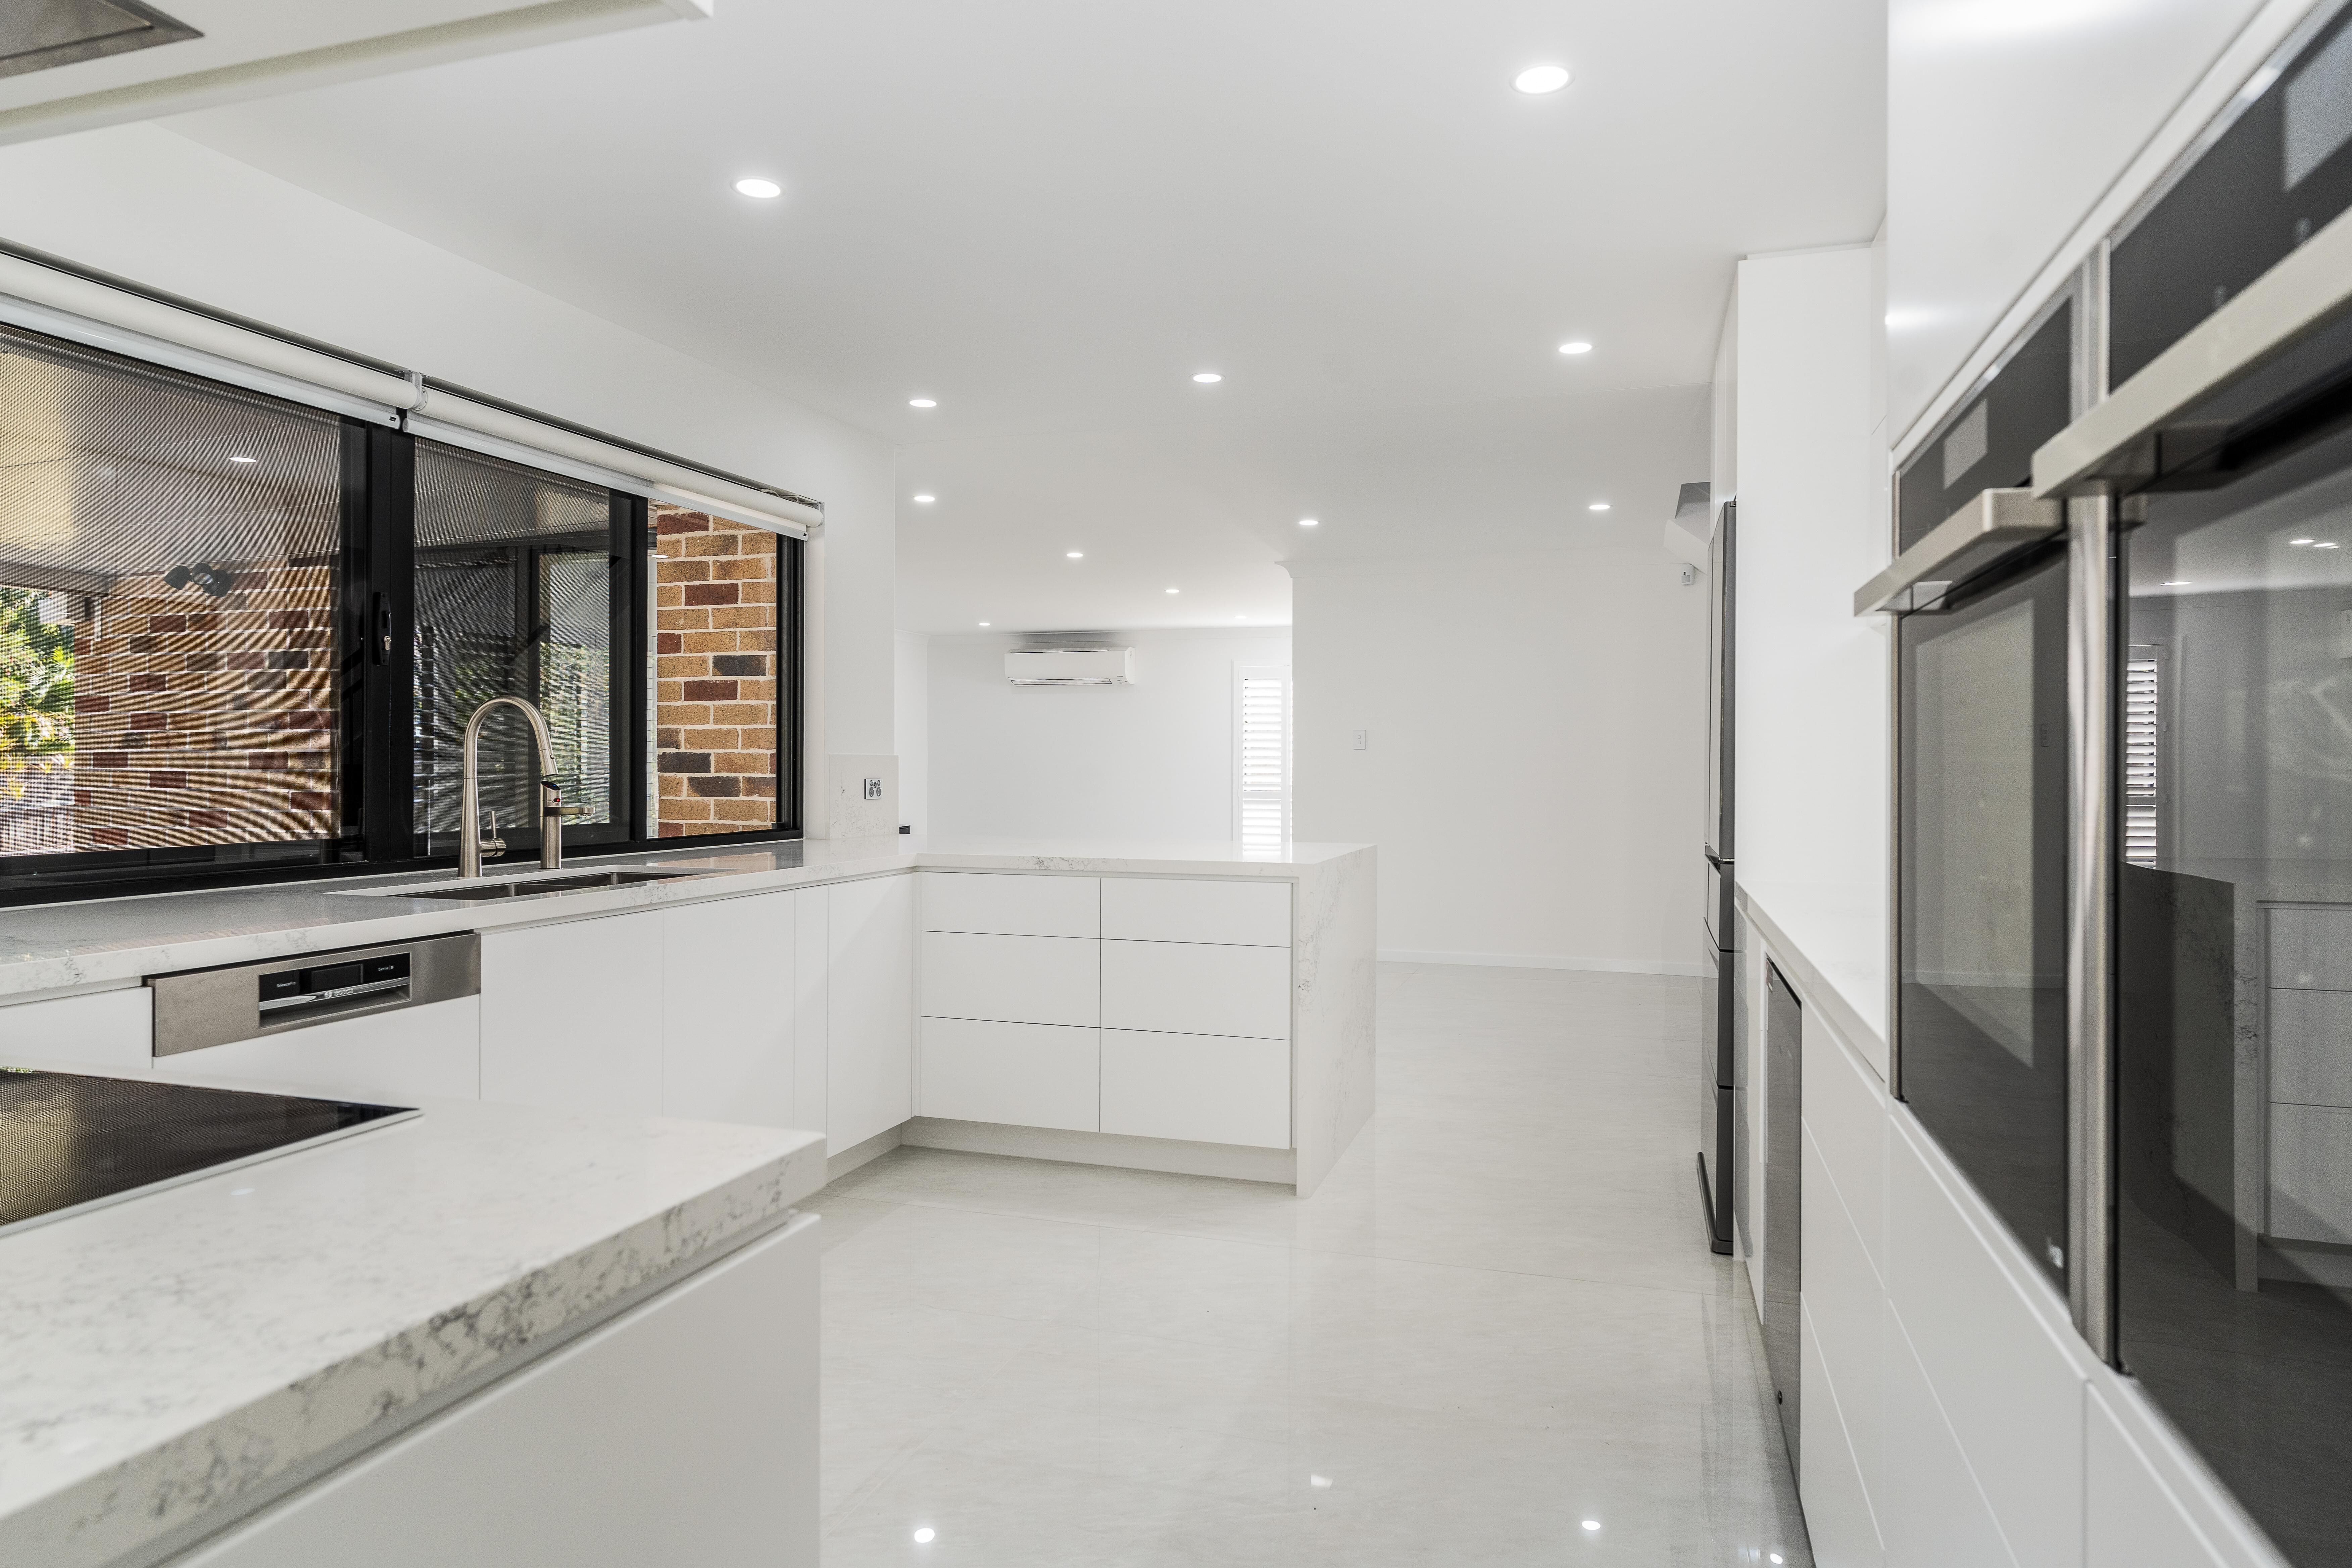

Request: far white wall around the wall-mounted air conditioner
left=922, top=628, right=1305, bottom=842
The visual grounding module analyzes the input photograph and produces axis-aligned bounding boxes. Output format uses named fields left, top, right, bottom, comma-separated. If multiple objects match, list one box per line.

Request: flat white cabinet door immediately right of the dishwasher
left=482, top=910, right=663, bottom=1117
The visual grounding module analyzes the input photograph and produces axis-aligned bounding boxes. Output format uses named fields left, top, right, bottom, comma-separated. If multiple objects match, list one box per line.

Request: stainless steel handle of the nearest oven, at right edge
left=2032, top=193, right=2352, bottom=496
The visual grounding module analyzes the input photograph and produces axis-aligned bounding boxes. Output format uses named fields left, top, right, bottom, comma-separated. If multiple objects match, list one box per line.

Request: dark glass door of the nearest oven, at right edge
left=2114, top=409, right=2352, bottom=1566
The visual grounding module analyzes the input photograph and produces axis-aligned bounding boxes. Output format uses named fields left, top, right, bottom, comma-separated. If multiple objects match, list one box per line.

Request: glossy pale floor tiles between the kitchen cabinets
left=812, top=966, right=1811, bottom=1568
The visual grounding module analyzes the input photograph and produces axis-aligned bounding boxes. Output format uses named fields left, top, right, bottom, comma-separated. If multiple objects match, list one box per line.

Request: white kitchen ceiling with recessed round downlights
left=147, top=0, right=1884, bottom=630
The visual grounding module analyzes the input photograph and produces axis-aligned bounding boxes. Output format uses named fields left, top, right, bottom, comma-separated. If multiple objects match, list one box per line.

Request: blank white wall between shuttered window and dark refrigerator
left=1291, top=545, right=1708, bottom=973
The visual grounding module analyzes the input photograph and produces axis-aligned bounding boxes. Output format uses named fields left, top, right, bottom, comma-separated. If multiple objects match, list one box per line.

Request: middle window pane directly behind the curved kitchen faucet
left=409, top=442, right=628, bottom=861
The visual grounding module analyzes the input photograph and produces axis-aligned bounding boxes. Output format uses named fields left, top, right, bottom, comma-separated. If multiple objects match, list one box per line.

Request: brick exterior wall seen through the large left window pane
left=73, top=557, right=339, bottom=849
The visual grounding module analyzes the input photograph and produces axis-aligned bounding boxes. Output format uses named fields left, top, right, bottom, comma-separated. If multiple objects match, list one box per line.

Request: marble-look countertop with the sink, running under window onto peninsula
left=0, top=835, right=1367, bottom=1001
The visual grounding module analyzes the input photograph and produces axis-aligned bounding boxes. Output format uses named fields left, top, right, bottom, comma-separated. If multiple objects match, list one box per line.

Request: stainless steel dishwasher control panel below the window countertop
left=146, top=931, right=482, bottom=1056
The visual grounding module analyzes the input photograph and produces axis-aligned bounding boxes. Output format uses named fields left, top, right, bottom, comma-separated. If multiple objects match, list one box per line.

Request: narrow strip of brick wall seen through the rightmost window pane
left=651, top=505, right=781, bottom=839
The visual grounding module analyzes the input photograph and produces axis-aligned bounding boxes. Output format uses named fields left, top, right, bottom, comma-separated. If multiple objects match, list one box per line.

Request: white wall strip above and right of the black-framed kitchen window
left=0, top=125, right=896, bottom=771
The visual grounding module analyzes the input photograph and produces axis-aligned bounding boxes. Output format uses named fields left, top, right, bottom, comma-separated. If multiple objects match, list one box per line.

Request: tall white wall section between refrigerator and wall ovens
left=1736, top=244, right=1889, bottom=1053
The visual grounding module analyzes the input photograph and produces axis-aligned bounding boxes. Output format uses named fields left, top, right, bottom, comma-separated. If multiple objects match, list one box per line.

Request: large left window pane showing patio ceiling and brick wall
left=0, top=332, right=348, bottom=886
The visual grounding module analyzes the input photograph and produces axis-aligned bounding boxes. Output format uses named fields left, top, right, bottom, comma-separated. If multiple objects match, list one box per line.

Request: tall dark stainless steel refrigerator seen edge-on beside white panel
left=1677, top=484, right=1738, bottom=1253
